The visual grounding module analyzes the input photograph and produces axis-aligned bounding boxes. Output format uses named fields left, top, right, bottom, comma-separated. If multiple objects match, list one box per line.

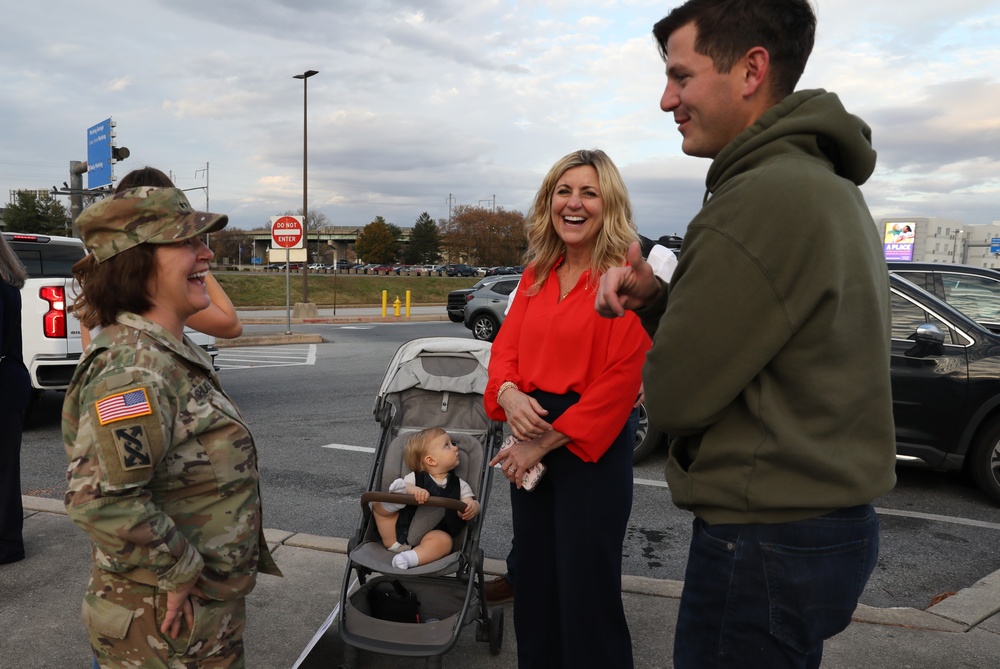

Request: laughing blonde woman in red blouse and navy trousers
left=485, top=150, right=650, bottom=669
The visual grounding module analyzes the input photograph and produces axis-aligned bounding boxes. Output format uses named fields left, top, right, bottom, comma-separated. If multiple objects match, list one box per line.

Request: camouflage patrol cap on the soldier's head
left=76, top=186, right=229, bottom=262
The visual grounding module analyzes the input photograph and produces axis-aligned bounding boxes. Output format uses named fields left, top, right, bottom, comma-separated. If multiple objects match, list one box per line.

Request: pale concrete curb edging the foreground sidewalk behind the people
left=21, top=495, right=1000, bottom=634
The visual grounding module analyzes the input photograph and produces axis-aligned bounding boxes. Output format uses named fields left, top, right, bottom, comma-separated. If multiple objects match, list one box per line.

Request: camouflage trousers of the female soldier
left=82, top=567, right=246, bottom=669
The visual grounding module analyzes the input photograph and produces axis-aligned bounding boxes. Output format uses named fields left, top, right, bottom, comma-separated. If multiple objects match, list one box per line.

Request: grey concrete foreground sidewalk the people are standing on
left=0, top=497, right=1000, bottom=669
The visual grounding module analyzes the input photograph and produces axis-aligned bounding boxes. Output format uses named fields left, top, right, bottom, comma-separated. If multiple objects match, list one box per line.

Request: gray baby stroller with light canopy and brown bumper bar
left=339, top=337, right=503, bottom=667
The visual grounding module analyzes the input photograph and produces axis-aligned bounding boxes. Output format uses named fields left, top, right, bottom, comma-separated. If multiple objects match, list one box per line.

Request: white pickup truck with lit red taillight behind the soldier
left=3, top=232, right=219, bottom=394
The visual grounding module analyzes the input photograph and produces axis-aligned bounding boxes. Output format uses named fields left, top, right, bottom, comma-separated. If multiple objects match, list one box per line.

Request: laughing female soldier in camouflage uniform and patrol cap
left=63, top=188, right=280, bottom=668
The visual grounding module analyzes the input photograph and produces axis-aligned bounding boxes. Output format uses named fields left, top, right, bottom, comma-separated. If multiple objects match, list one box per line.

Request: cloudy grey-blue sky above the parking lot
left=0, top=0, right=1000, bottom=236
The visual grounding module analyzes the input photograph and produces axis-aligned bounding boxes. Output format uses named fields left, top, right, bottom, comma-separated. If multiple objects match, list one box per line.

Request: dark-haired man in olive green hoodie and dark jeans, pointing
left=596, top=0, right=895, bottom=669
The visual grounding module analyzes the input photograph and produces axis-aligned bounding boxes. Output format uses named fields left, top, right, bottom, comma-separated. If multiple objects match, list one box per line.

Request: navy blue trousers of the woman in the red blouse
left=510, top=404, right=638, bottom=669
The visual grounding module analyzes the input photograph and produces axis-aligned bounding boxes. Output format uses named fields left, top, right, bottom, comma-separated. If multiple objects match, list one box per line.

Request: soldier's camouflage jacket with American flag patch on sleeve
left=62, top=312, right=280, bottom=600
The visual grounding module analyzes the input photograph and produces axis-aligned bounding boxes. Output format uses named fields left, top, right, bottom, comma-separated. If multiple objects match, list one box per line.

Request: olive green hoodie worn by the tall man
left=639, top=90, right=895, bottom=524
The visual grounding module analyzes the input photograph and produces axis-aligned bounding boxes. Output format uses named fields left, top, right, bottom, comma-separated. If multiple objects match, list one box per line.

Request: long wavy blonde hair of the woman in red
left=525, top=149, right=639, bottom=294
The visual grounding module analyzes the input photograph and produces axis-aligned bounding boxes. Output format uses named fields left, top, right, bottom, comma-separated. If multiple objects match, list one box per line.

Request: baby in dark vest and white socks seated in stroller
left=372, top=427, right=479, bottom=569
